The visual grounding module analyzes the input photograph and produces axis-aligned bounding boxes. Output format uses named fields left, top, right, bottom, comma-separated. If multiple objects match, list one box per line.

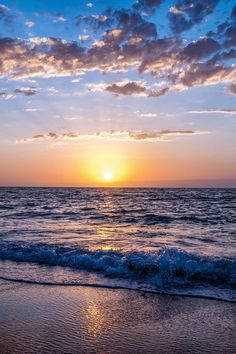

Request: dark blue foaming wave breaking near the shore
left=0, top=242, right=236, bottom=289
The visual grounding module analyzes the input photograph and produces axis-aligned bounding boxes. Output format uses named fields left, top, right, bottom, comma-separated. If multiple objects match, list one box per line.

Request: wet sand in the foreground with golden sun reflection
left=0, top=281, right=236, bottom=354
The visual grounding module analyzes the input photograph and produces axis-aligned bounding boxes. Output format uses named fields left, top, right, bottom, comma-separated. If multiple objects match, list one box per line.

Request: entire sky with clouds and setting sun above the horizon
left=0, top=0, right=236, bottom=187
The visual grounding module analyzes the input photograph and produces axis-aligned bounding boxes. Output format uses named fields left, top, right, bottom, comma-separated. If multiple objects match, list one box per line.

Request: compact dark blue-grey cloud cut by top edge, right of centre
left=169, top=0, right=219, bottom=33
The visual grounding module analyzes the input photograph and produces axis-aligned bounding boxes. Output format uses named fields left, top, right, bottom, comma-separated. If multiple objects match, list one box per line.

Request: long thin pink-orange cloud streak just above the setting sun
left=17, top=130, right=208, bottom=143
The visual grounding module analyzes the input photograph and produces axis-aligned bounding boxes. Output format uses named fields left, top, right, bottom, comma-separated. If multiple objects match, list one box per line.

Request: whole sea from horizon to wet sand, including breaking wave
left=0, top=188, right=236, bottom=301
